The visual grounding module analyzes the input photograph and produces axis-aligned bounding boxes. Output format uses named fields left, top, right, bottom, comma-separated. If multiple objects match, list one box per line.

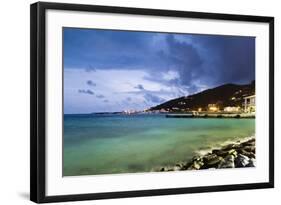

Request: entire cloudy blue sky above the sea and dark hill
left=63, top=28, right=255, bottom=113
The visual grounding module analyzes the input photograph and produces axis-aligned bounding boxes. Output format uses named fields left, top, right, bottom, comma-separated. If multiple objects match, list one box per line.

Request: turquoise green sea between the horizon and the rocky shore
left=63, top=114, right=255, bottom=176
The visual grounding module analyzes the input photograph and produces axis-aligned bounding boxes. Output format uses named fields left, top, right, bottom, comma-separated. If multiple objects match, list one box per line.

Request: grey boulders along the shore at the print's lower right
left=154, top=137, right=256, bottom=171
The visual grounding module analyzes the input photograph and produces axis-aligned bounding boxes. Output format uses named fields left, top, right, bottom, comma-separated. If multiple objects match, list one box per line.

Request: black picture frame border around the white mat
left=30, top=2, right=274, bottom=203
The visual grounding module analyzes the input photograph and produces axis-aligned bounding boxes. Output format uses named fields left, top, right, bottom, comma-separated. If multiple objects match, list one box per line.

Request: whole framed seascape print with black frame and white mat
left=30, top=2, right=274, bottom=203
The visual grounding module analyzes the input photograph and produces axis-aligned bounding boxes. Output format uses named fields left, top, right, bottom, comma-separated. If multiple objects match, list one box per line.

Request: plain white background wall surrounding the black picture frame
left=0, top=0, right=276, bottom=205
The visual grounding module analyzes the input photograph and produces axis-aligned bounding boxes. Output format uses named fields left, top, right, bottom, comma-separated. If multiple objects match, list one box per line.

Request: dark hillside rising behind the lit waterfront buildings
left=150, top=81, right=255, bottom=111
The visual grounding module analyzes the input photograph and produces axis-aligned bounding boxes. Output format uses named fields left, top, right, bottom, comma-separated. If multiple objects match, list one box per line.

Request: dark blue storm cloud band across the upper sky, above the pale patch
left=64, top=29, right=255, bottom=93
